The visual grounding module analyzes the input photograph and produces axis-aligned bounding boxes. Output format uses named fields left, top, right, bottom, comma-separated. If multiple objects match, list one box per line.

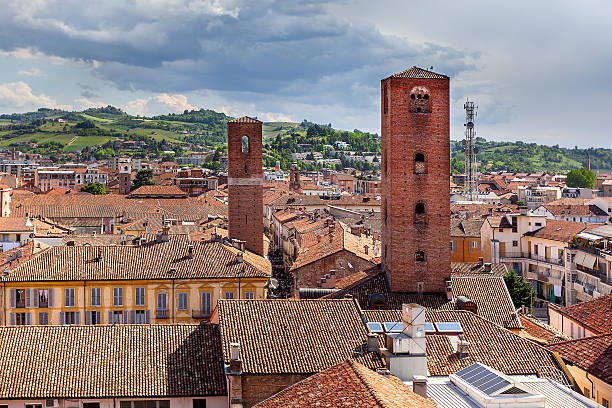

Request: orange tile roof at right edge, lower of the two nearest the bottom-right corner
left=548, top=333, right=612, bottom=385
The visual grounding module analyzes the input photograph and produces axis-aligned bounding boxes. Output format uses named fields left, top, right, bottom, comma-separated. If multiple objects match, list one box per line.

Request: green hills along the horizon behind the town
left=0, top=106, right=612, bottom=173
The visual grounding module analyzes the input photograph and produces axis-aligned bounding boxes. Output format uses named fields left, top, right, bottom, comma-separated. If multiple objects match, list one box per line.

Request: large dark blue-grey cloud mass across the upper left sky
left=0, top=0, right=478, bottom=98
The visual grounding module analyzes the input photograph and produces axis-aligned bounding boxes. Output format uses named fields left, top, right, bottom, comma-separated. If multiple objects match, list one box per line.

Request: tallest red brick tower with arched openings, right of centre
left=381, top=67, right=451, bottom=293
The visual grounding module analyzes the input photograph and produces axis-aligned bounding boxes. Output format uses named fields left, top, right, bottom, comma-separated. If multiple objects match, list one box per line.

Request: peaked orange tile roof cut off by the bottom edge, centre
left=255, top=360, right=438, bottom=408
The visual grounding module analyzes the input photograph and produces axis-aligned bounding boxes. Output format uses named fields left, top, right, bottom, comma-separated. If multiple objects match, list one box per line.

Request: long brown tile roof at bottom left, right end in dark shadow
left=0, top=324, right=227, bottom=399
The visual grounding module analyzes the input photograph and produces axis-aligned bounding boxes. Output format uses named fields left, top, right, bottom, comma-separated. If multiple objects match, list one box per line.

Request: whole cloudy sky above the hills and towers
left=0, top=0, right=612, bottom=148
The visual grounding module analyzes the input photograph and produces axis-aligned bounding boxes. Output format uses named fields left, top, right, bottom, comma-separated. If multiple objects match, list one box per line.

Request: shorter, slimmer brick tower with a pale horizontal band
left=227, top=116, right=264, bottom=255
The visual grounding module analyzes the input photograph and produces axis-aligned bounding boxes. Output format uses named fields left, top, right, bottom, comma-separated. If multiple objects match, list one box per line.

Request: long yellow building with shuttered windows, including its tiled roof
left=0, top=237, right=271, bottom=325
